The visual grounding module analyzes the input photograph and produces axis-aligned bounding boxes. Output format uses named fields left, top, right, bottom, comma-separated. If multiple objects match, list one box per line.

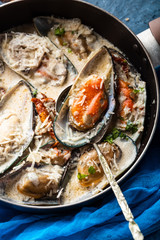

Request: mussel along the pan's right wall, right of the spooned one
left=109, top=49, right=147, bottom=141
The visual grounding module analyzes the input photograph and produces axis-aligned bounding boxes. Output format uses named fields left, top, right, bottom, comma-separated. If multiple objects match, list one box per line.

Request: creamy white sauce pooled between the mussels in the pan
left=0, top=17, right=143, bottom=208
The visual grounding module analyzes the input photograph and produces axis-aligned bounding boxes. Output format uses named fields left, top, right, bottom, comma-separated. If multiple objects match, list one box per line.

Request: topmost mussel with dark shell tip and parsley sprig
left=33, top=16, right=97, bottom=59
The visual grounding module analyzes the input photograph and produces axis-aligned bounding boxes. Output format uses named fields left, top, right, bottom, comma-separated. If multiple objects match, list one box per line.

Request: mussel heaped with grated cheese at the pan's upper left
left=0, top=32, right=77, bottom=86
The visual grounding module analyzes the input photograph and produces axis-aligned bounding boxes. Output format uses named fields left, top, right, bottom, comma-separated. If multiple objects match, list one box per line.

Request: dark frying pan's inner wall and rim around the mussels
left=0, top=0, right=159, bottom=213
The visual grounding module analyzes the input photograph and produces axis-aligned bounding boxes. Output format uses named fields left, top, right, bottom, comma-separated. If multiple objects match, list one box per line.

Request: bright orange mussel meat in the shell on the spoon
left=70, top=75, right=108, bottom=131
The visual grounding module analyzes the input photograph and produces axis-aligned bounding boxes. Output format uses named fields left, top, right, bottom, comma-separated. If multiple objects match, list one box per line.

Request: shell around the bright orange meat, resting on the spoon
left=54, top=46, right=115, bottom=147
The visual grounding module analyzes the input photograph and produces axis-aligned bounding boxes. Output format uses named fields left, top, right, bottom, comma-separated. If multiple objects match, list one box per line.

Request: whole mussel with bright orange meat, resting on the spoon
left=54, top=46, right=116, bottom=147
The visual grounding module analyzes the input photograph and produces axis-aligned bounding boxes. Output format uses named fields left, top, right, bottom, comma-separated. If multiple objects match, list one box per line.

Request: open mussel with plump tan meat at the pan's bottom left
left=0, top=150, right=79, bottom=206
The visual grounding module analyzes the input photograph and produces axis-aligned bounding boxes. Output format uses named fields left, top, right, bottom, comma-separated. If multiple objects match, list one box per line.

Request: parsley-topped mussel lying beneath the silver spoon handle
left=62, top=136, right=137, bottom=204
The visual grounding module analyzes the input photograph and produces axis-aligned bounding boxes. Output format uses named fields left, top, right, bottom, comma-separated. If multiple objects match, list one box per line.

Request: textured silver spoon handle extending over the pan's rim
left=93, top=143, right=144, bottom=240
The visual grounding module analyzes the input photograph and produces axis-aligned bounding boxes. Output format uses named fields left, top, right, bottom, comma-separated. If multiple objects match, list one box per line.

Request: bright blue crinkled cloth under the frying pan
left=0, top=67, right=160, bottom=240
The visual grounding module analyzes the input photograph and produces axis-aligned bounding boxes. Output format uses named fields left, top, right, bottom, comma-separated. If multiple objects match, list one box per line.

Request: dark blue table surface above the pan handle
left=86, top=0, right=160, bottom=34
